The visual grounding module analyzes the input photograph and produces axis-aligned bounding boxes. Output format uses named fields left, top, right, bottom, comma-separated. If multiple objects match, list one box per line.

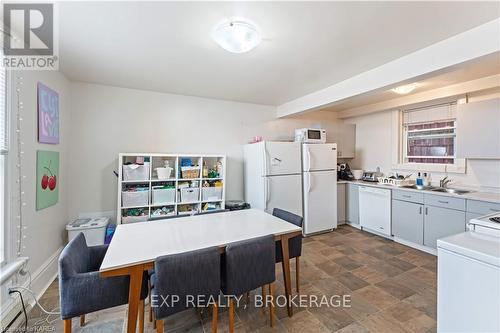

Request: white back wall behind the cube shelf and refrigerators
left=69, top=83, right=336, bottom=217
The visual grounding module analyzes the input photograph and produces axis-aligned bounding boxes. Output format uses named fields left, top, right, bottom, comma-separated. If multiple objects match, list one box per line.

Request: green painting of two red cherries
left=36, top=150, right=59, bottom=210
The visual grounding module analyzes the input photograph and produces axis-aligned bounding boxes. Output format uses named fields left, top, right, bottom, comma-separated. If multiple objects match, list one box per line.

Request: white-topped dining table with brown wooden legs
left=99, top=209, right=302, bottom=333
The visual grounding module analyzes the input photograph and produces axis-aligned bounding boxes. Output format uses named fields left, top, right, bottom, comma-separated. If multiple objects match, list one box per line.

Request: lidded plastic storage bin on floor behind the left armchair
left=66, top=217, right=109, bottom=246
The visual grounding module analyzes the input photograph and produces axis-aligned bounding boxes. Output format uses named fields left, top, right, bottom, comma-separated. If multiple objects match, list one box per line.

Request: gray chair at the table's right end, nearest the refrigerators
left=273, top=208, right=303, bottom=292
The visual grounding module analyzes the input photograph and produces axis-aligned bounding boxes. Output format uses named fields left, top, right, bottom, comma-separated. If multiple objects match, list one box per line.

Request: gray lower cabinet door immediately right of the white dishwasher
left=392, top=200, right=424, bottom=244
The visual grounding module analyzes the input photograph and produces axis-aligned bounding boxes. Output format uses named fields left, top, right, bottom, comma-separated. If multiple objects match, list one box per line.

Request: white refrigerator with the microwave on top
left=302, top=143, right=337, bottom=235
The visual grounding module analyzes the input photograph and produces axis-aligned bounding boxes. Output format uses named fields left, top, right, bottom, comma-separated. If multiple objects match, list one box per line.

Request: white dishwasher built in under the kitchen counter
left=359, top=186, right=391, bottom=237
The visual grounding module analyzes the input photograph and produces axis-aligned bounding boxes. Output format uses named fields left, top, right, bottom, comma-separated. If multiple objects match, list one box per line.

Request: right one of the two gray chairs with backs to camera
left=221, top=235, right=276, bottom=333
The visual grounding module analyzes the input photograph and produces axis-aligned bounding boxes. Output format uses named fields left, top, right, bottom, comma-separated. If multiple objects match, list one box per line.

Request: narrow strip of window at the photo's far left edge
left=0, top=52, right=9, bottom=263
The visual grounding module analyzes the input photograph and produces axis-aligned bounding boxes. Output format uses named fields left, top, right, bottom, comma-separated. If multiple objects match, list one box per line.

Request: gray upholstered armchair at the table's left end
left=59, top=233, right=148, bottom=333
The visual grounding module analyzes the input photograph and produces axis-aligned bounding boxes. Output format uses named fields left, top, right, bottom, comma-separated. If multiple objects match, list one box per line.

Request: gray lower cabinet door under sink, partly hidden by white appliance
left=424, top=206, right=465, bottom=248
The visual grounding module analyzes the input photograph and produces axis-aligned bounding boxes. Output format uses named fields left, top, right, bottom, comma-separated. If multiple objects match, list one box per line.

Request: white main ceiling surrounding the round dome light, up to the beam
left=59, top=2, right=500, bottom=105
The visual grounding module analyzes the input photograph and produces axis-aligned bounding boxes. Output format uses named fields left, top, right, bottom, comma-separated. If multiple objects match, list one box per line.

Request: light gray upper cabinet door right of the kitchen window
left=457, top=98, right=500, bottom=159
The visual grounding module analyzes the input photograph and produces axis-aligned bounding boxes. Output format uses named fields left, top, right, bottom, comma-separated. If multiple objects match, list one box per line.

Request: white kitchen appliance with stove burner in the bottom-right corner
left=437, top=213, right=500, bottom=332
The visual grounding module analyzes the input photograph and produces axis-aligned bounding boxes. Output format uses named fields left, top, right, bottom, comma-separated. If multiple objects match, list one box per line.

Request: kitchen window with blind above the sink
left=401, top=103, right=456, bottom=165
